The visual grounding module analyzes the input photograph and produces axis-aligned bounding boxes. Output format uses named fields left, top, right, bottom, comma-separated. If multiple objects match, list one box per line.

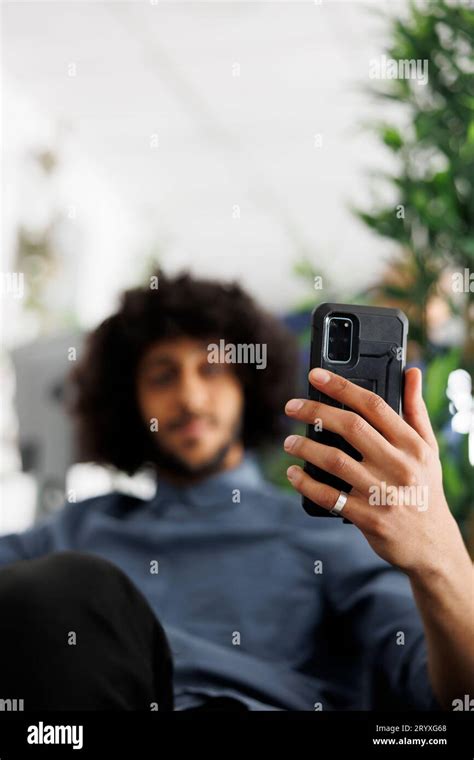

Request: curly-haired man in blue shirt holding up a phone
left=0, top=275, right=474, bottom=710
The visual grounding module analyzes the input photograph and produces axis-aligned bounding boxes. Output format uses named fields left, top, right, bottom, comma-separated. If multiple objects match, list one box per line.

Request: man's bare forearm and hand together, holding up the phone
left=285, top=369, right=474, bottom=709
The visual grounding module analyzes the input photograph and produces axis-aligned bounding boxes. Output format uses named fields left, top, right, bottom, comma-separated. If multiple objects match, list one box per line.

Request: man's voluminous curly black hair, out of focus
left=68, top=271, right=298, bottom=475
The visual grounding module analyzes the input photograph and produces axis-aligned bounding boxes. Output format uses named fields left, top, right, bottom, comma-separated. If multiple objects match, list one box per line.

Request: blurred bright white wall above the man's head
left=2, top=0, right=406, bottom=324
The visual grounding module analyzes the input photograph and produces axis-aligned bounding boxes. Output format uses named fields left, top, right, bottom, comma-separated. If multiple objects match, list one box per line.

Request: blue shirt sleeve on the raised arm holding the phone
left=327, top=525, right=442, bottom=710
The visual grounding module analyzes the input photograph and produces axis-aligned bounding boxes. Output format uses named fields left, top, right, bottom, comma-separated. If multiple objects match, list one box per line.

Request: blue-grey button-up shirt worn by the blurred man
left=0, top=454, right=438, bottom=710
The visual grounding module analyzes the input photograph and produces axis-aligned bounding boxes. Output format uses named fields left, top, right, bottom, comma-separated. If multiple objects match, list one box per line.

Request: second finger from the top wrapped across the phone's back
left=285, top=399, right=394, bottom=461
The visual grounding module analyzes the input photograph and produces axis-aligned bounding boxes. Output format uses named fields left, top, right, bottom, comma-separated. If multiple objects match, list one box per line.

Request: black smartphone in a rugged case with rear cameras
left=302, top=303, right=408, bottom=523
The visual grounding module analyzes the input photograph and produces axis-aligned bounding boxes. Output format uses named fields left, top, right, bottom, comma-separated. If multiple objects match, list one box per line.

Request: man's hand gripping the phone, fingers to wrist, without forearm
left=284, top=369, right=465, bottom=573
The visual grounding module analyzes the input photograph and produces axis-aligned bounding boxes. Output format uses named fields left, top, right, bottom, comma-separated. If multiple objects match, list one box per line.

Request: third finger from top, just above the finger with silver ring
left=283, top=435, right=374, bottom=495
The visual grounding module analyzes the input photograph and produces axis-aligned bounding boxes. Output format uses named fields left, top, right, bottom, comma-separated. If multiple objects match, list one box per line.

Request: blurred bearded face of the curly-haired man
left=137, top=337, right=244, bottom=475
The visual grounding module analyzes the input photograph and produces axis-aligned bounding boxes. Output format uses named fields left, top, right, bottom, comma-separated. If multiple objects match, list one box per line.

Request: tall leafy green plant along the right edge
left=356, top=0, right=474, bottom=552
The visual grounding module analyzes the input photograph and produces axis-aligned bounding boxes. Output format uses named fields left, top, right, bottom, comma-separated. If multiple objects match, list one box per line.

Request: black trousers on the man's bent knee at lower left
left=0, top=551, right=250, bottom=711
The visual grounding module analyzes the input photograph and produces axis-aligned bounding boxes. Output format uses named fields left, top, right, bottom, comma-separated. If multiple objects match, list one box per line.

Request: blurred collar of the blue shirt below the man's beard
left=152, top=452, right=265, bottom=507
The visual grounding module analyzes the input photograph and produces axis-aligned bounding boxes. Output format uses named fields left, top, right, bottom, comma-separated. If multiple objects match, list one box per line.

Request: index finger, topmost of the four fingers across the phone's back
left=309, top=368, right=419, bottom=449
